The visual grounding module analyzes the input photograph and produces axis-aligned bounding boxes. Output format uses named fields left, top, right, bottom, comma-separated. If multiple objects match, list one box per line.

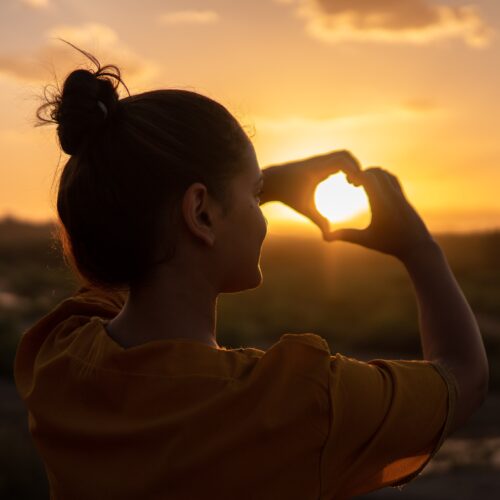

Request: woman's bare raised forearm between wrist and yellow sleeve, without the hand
left=402, top=242, right=488, bottom=432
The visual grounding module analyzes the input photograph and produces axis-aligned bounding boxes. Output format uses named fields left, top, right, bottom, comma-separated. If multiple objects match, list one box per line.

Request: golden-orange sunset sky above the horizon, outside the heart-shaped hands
left=0, top=0, right=500, bottom=231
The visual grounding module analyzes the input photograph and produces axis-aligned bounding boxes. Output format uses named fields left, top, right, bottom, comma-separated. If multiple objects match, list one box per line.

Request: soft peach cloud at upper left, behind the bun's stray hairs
left=0, top=23, right=159, bottom=83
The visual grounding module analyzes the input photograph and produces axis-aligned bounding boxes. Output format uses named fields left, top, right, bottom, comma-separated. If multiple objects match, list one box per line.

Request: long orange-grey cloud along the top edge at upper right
left=275, top=0, right=493, bottom=48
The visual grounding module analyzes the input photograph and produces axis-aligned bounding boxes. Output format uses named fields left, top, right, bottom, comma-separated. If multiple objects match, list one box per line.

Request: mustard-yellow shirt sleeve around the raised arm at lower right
left=321, top=354, right=457, bottom=499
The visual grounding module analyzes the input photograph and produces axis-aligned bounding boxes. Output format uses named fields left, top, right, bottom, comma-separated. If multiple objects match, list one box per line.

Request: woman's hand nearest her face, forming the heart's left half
left=261, top=150, right=361, bottom=239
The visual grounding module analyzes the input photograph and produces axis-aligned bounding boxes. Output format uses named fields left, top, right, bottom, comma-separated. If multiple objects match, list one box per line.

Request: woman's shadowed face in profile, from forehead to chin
left=219, top=141, right=267, bottom=292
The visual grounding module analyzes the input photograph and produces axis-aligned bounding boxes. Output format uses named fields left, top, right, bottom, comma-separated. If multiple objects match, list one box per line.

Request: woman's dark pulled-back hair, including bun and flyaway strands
left=37, top=42, right=249, bottom=289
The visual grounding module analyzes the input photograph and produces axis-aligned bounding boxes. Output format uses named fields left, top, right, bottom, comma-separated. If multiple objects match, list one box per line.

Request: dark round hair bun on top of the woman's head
left=52, top=69, right=118, bottom=155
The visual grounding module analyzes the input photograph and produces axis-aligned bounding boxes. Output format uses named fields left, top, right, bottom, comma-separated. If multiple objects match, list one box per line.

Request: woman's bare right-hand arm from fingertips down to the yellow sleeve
left=328, top=168, right=489, bottom=430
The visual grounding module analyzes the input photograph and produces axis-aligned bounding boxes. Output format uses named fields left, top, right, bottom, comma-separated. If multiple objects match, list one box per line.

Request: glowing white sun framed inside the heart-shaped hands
left=314, top=173, right=370, bottom=222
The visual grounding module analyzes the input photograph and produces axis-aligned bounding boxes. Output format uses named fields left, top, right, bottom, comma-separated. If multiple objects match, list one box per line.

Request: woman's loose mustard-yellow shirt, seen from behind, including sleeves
left=14, top=287, right=456, bottom=500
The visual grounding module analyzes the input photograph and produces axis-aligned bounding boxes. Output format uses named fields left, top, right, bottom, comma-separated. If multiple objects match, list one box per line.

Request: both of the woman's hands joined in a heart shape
left=264, top=150, right=435, bottom=260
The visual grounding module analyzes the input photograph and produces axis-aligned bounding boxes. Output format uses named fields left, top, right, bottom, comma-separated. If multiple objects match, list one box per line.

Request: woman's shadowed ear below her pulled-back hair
left=182, top=182, right=215, bottom=246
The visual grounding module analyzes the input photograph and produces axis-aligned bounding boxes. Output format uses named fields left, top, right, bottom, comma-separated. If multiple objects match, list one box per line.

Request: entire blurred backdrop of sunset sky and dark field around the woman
left=0, top=0, right=500, bottom=499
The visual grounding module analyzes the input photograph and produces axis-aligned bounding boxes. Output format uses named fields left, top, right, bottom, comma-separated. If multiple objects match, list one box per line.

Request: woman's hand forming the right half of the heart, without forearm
left=325, top=167, right=435, bottom=262
